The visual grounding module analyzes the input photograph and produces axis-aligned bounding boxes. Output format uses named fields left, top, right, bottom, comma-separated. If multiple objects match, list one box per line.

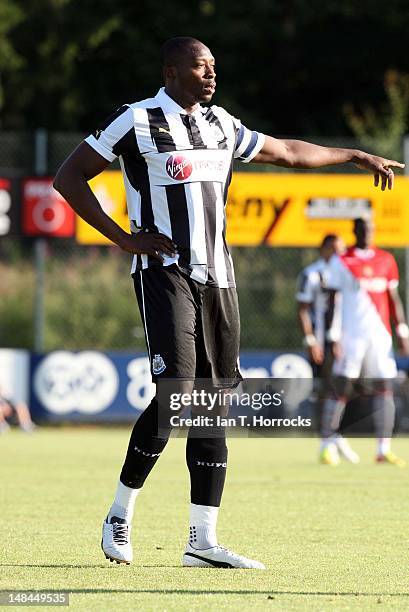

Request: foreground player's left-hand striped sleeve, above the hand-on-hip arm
left=85, top=104, right=133, bottom=162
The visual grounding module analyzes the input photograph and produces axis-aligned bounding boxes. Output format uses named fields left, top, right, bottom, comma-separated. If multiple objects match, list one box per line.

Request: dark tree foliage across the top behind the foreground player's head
left=0, top=0, right=409, bottom=136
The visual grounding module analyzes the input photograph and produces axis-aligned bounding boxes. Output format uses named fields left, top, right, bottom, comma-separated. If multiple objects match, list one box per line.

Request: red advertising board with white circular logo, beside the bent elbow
left=23, top=178, right=75, bottom=238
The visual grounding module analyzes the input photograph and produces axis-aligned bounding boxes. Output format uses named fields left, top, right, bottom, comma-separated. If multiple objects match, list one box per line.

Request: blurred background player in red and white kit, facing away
left=321, top=218, right=409, bottom=467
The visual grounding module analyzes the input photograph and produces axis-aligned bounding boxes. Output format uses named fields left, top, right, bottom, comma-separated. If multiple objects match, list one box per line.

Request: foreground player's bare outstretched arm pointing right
left=252, top=136, right=405, bottom=191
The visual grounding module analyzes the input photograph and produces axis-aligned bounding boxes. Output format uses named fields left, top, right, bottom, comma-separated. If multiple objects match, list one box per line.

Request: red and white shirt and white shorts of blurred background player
left=328, top=247, right=399, bottom=378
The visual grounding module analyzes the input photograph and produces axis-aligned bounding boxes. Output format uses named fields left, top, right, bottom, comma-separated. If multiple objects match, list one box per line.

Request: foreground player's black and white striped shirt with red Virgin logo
left=85, top=88, right=265, bottom=288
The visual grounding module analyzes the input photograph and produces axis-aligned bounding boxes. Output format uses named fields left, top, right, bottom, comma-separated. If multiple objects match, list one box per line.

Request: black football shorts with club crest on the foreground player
left=133, top=265, right=242, bottom=388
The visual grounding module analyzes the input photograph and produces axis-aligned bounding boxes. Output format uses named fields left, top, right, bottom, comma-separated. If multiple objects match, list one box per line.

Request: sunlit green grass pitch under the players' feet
left=0, top=427, right=409, bottom=611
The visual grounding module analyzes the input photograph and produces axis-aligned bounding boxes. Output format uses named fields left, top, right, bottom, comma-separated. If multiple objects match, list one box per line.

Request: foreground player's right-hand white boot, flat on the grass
left=182, top=544, right=266, bottom=569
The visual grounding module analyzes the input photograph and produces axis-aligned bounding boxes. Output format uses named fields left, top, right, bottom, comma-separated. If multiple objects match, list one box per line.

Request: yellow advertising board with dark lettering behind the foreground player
left=77, top=171, right=409, bottom=247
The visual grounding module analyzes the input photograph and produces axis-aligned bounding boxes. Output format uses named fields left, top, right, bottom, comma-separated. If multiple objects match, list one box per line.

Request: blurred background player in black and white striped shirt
left=296, top=234, right=359, bottom=465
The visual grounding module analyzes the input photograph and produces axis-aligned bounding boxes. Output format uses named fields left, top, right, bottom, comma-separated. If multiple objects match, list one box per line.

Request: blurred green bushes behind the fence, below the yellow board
left=0, top=243, right=405, bottom=351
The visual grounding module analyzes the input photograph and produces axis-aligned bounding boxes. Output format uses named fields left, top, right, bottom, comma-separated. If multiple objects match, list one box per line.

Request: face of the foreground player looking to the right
left=174, top=45, right=216, bottom=105
